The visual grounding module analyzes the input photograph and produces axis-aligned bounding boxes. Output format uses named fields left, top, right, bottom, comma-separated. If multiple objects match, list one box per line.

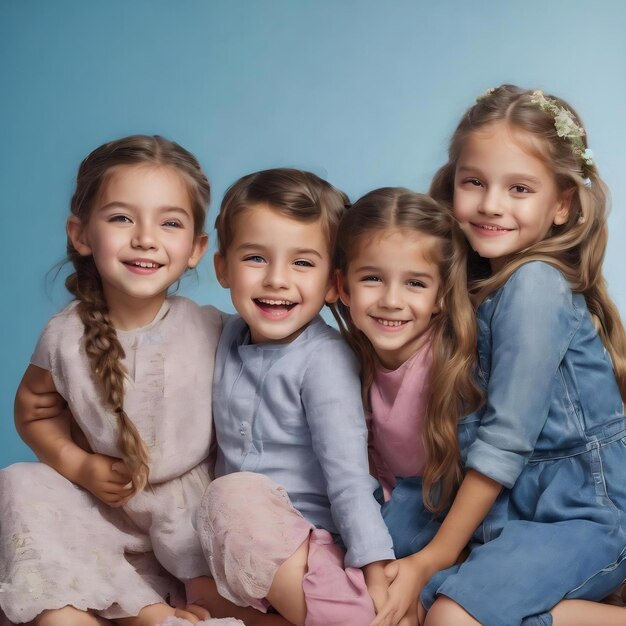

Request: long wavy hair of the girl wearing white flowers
left=430, top=85, right=626, bottom=400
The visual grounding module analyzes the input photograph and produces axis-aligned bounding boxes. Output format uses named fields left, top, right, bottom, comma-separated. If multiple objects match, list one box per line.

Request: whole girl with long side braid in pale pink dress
left=0, top=136, right=239, bottom=626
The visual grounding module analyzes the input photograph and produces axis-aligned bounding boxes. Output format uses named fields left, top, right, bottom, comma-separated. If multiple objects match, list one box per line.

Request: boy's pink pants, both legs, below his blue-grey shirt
left=197, top=472, right=375, bottom=626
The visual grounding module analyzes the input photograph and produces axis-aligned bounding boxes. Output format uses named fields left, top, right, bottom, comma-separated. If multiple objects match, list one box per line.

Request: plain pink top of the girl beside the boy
left=369, top=339, right=432, bottom=500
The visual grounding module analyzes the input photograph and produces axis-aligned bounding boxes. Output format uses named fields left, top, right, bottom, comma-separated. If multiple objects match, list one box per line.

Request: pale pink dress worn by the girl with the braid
left=0, top=296, right=222, bottom=623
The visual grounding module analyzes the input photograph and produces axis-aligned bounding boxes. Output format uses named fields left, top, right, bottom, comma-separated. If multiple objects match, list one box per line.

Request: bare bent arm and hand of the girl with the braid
left=15, top=365, right=132, bottom=506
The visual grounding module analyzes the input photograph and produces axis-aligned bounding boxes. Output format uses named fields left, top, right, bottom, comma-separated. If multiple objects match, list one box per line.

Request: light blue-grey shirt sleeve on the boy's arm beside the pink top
left=302, top=338, right=394, bottom=567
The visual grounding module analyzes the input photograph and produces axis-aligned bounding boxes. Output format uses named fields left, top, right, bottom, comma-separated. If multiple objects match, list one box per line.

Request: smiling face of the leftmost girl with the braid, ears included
left=67, top=164, right=207, bottom=329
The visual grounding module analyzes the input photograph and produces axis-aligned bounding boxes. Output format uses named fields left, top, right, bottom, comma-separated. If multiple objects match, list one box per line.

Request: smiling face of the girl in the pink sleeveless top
left=339, top=229, right=441, bottom=369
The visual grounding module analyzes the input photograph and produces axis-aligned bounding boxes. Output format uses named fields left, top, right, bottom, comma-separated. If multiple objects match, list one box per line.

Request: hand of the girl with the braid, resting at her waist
left=79, top=453, right=134, bottom=507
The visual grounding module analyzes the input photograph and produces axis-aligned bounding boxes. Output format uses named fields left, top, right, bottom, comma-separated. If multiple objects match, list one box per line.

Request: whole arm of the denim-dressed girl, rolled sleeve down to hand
left=374, top=262, right=582, bottom=626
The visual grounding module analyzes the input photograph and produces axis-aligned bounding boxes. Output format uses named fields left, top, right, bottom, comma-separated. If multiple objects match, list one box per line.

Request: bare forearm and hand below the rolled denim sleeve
left=372, top=470, right=502, bottom=626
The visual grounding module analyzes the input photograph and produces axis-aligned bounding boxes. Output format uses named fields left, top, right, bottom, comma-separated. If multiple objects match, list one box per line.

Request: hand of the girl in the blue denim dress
left=371, top=552, right=434, bottom=626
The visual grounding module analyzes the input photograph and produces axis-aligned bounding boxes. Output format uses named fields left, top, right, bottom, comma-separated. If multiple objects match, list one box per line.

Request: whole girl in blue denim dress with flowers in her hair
left=374, top=85, right=626, bottom=626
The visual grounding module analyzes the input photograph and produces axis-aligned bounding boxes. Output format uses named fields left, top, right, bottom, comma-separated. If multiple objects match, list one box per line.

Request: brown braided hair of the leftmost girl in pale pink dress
left=65, top=135, right=210, bottom=492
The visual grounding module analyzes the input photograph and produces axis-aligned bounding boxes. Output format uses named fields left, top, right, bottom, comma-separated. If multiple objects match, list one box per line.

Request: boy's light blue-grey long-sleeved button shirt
left=213, top=316, right=394, bottom=567
